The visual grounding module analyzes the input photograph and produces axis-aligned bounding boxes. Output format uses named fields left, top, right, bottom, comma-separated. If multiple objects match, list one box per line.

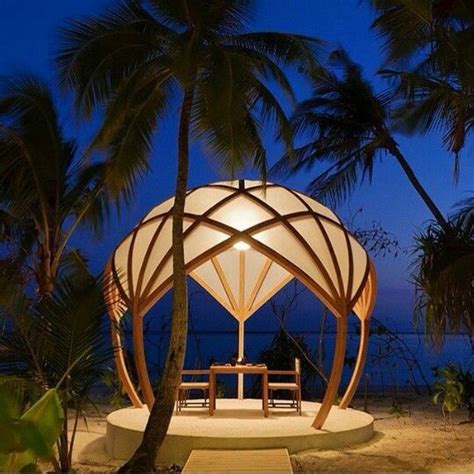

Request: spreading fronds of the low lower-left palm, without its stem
left=0, top=270, right=113, bottom=398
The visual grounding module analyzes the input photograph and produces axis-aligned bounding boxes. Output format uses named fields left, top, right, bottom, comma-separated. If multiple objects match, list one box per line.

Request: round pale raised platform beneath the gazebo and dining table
left=106, top=399, right=374, bottom=465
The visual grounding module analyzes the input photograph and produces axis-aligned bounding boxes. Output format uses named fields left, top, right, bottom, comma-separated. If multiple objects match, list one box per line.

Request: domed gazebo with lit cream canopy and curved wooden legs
left=106, top=180, right=376, bottom=429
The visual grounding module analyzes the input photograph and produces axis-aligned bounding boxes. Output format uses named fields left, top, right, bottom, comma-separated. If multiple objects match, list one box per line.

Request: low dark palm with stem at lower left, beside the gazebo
left=0, top=271, right=113, bottom=471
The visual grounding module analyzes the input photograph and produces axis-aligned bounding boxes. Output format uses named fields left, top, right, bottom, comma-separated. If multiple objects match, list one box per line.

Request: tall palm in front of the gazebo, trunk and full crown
left=58, top=0, right=319, bottom=471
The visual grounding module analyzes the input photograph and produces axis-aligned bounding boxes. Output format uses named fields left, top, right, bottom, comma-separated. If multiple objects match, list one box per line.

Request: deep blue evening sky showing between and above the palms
left=0, top=0, right=474, bottom=326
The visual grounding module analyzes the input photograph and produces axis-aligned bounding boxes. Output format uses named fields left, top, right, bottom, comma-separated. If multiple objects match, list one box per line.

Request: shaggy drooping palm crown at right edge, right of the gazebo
left=413, top=194, right=474, bottom=345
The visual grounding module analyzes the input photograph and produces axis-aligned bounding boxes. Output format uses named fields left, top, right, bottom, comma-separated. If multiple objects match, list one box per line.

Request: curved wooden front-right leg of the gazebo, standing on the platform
left=312, top=316, right=347, bottom=430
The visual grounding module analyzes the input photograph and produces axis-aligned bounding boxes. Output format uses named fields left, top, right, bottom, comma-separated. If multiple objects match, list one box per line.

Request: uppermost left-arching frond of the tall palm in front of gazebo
left=56, top=1, right=175, bottom=117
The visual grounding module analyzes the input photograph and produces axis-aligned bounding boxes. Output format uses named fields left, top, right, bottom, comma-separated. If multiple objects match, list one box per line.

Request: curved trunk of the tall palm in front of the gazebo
left=119, top=89, right=193, bottom=472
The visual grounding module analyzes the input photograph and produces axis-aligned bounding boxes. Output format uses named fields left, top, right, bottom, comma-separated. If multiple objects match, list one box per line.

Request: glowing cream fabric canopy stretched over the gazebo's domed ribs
left=112, top=181, right=369, bottom=320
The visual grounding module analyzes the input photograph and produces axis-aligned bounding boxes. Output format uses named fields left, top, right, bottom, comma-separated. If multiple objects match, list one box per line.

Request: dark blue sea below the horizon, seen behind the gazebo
left=136, top=331, right=474, bottom=395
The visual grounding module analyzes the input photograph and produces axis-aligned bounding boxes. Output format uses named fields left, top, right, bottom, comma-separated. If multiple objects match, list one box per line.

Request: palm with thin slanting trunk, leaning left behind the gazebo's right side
left=274, top=50, right=446, bottom=226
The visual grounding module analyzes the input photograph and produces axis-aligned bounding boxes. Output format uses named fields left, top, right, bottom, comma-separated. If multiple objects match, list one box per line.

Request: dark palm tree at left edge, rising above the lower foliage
left=0, top=75, right=114, bottom=294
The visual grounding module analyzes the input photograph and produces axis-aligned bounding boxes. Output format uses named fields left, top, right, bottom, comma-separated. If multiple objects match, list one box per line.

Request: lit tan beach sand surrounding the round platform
left=70, top=398, right=474, bottom=472
